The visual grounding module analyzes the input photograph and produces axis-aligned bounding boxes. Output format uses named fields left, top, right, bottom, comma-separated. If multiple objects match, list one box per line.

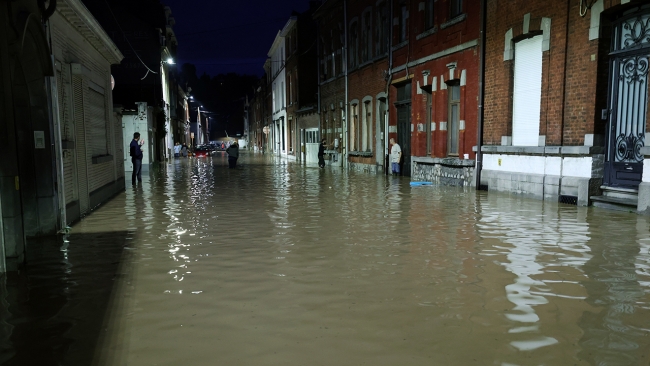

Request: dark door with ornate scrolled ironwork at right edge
left=605, top=6, right=650, bottom=188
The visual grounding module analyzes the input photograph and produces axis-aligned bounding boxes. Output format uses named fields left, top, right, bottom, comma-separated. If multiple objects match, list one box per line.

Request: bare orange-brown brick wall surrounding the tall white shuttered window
left=483, top=0, right=650, bottom=146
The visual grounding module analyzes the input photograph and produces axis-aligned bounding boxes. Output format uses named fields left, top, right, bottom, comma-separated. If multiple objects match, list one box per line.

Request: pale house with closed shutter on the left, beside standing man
left=50, top=0, right=128, bottom=223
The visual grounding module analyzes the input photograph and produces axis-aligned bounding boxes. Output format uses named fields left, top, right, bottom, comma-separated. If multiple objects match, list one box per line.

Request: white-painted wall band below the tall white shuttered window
left=483, top=154, right=592, bottom=181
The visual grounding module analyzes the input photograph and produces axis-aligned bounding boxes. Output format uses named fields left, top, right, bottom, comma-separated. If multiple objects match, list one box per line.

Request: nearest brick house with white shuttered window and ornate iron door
left=480, top=0, right=650, bottom=212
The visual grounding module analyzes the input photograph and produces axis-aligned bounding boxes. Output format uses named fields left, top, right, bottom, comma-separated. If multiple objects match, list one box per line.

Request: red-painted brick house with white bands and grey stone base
left=389, top=0, right=481, bottom=182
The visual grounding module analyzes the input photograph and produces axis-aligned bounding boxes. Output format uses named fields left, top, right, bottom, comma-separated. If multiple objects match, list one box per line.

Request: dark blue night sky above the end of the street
left=161, top=0, right=309, bottom=76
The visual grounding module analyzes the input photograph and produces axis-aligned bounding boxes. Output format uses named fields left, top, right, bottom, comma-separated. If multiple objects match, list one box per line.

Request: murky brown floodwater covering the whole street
left=0, top=153, right=650, bottom=365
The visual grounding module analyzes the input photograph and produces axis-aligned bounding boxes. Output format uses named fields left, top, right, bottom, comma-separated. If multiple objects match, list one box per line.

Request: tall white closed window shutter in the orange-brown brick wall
left=512, top=35, right=542, bottom=146
